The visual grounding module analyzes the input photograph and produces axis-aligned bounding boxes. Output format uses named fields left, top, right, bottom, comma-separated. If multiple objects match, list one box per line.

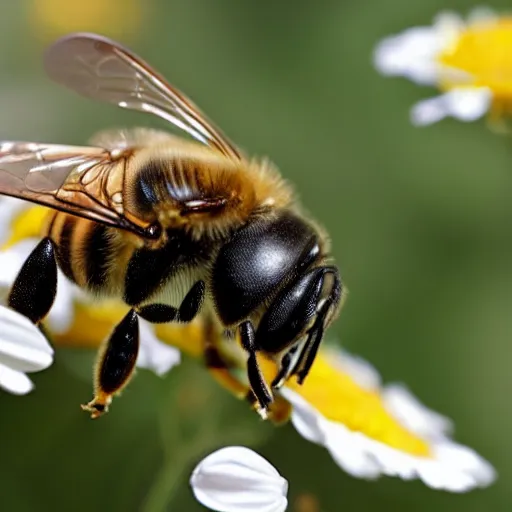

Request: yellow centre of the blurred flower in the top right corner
left=439, top=17, right=512, bottom=110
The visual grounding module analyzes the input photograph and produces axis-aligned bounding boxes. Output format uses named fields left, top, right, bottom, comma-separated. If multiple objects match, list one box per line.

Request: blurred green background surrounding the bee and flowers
left=0, top=0, right=512, bottom=512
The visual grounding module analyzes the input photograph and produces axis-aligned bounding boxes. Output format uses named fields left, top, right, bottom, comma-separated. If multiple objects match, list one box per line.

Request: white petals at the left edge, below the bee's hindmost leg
left=0, top=306, right=53, bottom=395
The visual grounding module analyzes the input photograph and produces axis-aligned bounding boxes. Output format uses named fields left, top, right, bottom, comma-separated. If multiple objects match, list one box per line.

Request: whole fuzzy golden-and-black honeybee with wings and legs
left=0, top=33, right=342, bottom=418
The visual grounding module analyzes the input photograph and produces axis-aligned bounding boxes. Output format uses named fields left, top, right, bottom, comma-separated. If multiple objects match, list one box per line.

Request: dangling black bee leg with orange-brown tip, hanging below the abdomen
left=82, top=309, right=139, bottom=419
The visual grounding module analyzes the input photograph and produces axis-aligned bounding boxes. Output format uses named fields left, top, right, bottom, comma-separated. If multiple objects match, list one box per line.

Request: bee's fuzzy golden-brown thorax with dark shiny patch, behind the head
left=124, top=139, right=291, bottom=239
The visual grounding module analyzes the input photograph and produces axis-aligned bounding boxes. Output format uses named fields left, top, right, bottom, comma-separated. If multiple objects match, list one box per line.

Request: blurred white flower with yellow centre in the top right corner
left=374, top=8, right=512, bottom=125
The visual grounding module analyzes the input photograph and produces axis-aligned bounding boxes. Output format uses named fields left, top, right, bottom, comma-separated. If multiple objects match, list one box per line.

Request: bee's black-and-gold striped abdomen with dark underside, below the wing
left=48, top=212, right=213, bottom=306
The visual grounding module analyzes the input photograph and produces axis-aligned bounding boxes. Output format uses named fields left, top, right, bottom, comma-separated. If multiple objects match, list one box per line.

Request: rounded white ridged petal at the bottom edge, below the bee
left=190, top=446, right=288, bottom=512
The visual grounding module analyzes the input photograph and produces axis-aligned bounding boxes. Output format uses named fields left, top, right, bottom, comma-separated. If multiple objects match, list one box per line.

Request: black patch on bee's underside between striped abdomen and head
left=124, top=230, right=212, bottom=306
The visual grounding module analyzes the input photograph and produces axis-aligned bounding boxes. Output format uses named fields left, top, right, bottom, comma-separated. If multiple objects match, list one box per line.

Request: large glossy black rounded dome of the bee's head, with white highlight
left=211, top=211, right=319, bottom=325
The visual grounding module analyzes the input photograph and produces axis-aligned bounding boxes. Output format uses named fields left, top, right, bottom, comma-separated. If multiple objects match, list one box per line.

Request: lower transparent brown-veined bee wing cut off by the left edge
left=0, top=141, right=152, bottom=236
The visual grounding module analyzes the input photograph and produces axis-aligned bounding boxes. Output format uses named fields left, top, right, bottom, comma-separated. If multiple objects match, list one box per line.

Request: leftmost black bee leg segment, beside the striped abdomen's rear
left=7, top=237, right=57, bottom=325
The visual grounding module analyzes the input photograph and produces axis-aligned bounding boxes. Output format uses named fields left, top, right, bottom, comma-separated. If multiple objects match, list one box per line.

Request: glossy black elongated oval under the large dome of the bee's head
left=256, top=267, right=325, bottom=353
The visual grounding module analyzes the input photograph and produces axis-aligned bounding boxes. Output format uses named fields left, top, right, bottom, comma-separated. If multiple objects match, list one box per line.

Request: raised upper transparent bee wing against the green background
left=45, top=33, right=241, bottom=159
